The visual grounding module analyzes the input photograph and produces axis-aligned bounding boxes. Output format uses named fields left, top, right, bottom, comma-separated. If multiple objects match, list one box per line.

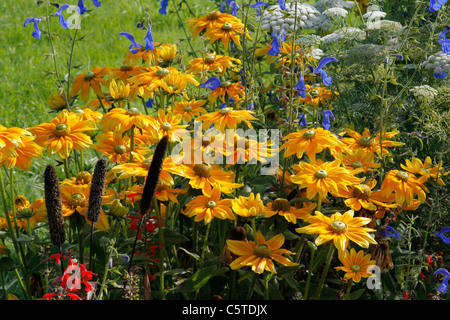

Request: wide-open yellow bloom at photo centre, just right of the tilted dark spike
left=182, top=163, right=242, bottom=197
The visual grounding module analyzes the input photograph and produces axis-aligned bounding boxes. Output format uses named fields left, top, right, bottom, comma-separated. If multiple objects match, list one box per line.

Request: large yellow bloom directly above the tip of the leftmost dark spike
left=28, top=110, right=97, bottom=159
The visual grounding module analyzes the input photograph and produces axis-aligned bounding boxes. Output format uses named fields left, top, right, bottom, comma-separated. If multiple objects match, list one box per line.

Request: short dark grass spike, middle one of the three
left=87, top=159, right=107, bottom=222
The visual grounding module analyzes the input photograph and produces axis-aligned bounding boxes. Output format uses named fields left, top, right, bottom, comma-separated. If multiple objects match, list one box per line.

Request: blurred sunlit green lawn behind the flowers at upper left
left=0, top=0, right=214, bottom=200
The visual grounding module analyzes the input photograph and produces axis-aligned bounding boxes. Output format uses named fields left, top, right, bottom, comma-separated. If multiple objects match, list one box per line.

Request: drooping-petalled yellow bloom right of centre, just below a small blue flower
left=280, top=128, right=345, bottom=163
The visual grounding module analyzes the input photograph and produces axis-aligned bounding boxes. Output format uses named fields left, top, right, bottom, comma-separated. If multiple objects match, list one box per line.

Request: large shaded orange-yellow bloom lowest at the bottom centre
left=227, top=231, right=298, bottom=274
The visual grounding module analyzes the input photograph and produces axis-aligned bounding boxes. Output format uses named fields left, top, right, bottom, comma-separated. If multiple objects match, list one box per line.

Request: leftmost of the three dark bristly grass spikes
left=44, top=164, right=66, bottom=247
